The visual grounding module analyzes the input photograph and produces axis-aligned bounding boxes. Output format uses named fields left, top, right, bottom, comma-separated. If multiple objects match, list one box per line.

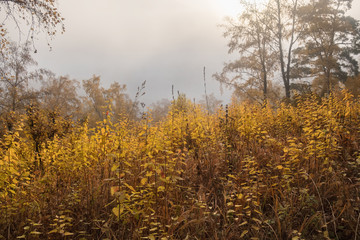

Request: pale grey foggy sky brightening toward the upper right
left=4, top=0, right=360, bottom=103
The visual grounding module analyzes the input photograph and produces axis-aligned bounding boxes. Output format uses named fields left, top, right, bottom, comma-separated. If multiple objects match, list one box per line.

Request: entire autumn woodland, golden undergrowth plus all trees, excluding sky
left=0, top=0, right=360, bottom=240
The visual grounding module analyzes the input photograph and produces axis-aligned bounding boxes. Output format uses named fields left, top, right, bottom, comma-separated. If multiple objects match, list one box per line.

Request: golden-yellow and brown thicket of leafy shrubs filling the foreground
left=0, top=92, right=360, bottom=240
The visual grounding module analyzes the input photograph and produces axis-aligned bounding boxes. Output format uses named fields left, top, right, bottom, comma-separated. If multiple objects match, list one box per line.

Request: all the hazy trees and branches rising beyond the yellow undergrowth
left=0, top=0, right=360, bottom=132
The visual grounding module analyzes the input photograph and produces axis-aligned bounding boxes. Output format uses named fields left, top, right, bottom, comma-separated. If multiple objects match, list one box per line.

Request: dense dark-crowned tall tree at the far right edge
left=297, top=0, right=360, bottom=95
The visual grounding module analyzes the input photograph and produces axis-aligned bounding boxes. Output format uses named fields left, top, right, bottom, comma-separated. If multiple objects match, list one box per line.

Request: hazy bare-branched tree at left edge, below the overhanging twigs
left=0, top=42, right=46, bottom=112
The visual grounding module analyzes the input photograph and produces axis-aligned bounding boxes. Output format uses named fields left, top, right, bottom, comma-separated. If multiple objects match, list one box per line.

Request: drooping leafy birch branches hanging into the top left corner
left=0, top=0, right=65, bottom=46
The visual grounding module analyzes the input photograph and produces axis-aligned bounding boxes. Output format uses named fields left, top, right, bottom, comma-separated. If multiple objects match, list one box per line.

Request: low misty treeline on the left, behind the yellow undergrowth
left=0, top=42, right=170, bottom=134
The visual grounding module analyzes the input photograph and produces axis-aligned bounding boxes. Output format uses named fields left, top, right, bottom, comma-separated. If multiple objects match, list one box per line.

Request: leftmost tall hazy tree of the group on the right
left=214, top=2, right=276, bottom=102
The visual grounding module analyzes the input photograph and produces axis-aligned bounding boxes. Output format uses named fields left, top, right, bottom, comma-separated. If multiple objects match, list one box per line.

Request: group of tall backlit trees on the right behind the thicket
left=214, top=0, right=360, bottom=103
